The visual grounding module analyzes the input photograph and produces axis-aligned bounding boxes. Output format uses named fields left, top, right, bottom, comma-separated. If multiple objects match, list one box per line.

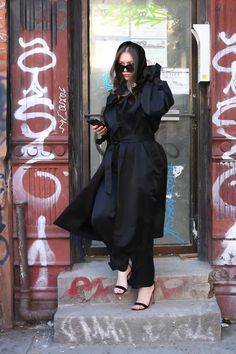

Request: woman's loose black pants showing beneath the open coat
left=92, top=173, right=154, bottom=288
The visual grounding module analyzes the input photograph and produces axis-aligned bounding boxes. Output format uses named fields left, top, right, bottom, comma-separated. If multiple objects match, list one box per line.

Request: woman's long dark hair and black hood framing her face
left=110, top=41, right=147, bottom=96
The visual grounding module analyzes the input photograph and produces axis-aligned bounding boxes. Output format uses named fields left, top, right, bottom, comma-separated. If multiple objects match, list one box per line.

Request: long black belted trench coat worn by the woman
left=54, top=64, right=174, bottom=243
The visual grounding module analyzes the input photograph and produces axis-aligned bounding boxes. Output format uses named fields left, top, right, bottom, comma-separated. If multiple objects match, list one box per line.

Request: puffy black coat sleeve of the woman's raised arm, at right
left=141, top=64, right=174, bottom=121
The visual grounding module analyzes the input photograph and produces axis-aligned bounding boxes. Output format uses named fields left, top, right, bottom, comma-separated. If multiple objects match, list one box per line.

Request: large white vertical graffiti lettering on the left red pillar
left=13, top=38, right=63, bottom=289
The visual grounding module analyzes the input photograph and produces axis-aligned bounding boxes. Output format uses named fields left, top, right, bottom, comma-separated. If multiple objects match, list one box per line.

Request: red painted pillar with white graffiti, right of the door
left=209, top=0, right=236, bottom=319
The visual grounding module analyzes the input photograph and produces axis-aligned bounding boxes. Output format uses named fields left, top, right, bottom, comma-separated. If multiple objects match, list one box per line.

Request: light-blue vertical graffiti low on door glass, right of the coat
left=165, top=163, right=186, bottom=243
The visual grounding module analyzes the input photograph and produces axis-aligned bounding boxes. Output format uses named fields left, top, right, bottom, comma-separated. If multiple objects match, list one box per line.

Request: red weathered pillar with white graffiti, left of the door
left=10, top=0, right=70, bottom=316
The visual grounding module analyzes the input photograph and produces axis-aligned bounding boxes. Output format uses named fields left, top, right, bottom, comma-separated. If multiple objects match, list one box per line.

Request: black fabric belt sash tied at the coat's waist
left=104, top=134, right=155, bottom=194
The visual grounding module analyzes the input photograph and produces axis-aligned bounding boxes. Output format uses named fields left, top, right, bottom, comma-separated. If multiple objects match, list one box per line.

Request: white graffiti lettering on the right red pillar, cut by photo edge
left=212, top=32, right=236, bottom=265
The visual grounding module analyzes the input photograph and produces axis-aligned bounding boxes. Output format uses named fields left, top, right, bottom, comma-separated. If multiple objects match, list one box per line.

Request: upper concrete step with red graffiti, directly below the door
left=58, top=256, right=211, bottom=304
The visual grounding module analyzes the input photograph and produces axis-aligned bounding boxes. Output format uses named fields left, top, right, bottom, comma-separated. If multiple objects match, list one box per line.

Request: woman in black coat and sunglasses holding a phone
left=55, top=41, right=174, bottom=311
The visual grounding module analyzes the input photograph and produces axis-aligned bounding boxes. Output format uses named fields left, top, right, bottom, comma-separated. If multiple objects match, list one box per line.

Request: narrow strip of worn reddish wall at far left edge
left=0, top=0, right=13, bottom=328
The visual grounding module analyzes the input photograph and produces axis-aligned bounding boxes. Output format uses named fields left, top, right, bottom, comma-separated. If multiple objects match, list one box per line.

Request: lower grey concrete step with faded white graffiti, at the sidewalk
left=54, top=299, right=221, bottom=345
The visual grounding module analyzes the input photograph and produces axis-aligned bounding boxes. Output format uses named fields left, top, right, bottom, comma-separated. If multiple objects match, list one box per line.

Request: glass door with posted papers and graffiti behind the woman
left=76, top=0, right=197, bottom=254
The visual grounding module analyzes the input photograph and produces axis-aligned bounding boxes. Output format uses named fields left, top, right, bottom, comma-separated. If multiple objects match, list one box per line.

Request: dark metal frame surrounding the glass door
left=70, top=0, right=210, bottom=260
